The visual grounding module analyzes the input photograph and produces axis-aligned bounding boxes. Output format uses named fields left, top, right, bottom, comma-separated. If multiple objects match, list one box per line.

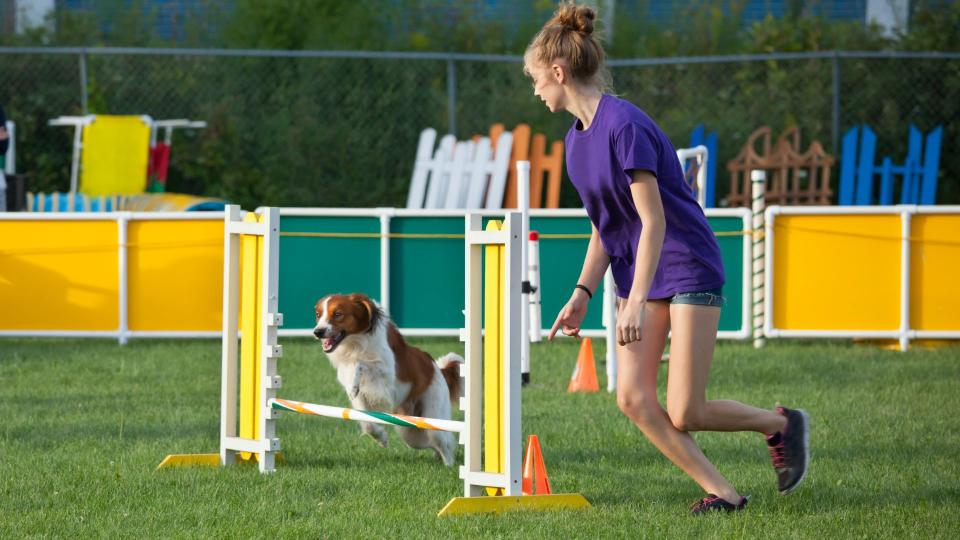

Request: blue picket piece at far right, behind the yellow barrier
left=838, top=124, right=943, bottom=206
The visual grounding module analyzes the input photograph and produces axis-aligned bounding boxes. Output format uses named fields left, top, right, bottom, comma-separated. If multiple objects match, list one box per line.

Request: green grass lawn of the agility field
left=0, top=339, right=960, bottom=538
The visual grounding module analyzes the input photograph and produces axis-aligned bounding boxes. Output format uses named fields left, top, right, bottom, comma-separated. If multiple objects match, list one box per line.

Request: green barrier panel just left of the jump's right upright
left=390, top=216, right=465, bottom=329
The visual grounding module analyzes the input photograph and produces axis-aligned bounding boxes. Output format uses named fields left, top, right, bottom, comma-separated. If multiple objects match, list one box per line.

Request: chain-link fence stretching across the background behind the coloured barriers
left=0, top=48, right=960, bottom=208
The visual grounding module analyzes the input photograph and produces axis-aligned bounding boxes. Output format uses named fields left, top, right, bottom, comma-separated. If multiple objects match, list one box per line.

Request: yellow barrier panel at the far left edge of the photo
left=0, top=221, right=120, bottom=331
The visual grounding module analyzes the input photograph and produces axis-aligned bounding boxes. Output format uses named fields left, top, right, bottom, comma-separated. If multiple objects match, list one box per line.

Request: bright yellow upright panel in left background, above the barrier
left=80, top=115, right=150, bottom=195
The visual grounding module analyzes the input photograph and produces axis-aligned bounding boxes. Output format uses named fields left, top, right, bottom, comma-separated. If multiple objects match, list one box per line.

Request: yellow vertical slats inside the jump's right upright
left=483, top=220, right=504, bottom=495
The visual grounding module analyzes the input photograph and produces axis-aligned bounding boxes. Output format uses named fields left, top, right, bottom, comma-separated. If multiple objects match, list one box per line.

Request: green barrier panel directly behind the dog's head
left=279, top=216, right=380, bottom=330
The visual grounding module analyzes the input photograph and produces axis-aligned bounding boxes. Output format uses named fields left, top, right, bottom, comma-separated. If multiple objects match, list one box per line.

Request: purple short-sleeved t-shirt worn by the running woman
left=565, top=94, right=724, bottom=300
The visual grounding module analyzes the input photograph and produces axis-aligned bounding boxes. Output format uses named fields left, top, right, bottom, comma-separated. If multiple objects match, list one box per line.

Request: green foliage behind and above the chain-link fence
left=0, top=0, right=960, bottom=207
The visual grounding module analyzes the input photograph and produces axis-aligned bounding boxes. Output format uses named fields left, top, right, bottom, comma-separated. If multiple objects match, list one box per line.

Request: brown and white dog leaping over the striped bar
left=313, top=294, right=463, bottom=466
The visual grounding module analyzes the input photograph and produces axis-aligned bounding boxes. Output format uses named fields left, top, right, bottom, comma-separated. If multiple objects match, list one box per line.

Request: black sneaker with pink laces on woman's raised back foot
left=767, top=407, right=810, bottom=495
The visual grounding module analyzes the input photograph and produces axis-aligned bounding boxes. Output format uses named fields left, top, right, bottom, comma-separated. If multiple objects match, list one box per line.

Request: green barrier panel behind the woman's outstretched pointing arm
left=530, top=216, right=603, bottom=330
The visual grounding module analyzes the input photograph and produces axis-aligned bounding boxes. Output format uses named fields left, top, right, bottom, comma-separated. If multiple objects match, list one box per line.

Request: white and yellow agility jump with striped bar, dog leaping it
left=158, top=206, right=590, bottom=515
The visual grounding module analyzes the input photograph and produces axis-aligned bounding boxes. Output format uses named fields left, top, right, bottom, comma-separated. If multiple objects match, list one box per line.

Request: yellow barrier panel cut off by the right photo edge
left=910, top=214, right=960, bottom=330
